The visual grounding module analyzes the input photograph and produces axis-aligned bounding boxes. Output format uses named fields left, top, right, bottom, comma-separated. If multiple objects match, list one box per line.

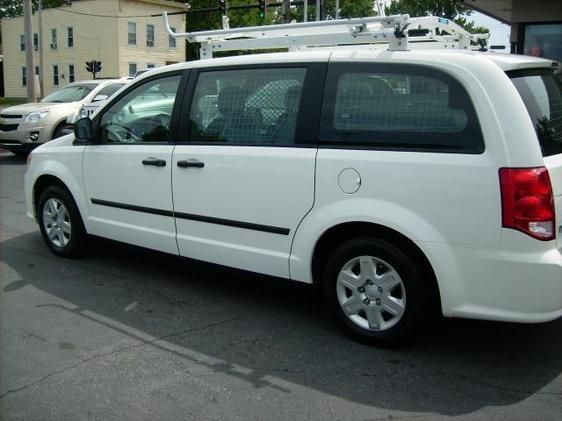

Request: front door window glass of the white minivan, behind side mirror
left=99, top=75, right=181, bottom=143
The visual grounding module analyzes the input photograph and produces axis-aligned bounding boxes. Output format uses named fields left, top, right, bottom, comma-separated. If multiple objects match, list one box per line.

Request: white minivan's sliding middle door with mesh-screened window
left=172, top=64, right=324, bottom=277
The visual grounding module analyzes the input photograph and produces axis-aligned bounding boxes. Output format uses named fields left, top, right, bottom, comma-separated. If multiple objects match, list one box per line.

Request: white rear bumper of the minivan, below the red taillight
left=424, top=230, right=562, bottom=323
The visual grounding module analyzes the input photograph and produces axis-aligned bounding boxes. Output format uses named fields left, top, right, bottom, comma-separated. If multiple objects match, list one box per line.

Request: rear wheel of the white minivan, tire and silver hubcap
left=323, top=237, right=426, bottom=345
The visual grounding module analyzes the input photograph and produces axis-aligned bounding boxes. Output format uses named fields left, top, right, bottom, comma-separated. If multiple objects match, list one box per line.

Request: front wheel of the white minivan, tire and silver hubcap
left=37, top=186, right=86, bottom=257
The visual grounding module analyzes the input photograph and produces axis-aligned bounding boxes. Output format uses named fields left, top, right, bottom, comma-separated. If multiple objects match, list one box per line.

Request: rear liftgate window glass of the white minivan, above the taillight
left=507, top=69, right=562, bottom=156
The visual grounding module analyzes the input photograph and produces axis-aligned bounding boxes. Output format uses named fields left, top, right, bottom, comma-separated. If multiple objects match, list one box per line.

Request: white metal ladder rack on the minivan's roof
left=162, top=12, right=489, bottom=59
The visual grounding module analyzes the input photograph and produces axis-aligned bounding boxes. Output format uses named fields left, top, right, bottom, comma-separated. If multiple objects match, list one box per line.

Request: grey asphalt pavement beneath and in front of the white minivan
left=0, top=153, right=562, bottom=421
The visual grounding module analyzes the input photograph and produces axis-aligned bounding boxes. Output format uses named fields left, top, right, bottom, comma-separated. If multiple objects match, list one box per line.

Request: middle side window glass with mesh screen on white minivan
left=190, top=68, right=306, bottom=144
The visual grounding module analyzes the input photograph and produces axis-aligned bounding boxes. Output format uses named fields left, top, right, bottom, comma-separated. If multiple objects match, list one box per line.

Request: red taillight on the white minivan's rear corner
left=500, top=167, right=556, bottom=241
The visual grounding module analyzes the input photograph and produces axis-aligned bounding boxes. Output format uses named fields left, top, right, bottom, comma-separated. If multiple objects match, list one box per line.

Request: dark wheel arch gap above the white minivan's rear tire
left=311, top=221, right=442, bottom=311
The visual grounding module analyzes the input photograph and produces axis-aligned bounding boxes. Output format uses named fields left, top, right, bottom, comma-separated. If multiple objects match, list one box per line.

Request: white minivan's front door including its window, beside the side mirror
left=83, top=73, right=181, bottom=254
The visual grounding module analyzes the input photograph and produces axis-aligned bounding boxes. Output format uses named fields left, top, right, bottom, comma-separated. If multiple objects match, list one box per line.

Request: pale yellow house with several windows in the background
left=2, top=0, right=186, bottom=97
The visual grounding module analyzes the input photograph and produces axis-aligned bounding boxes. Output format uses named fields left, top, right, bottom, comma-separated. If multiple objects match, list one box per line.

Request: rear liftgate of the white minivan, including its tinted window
left=507, top=68, right=562, bottom=248
